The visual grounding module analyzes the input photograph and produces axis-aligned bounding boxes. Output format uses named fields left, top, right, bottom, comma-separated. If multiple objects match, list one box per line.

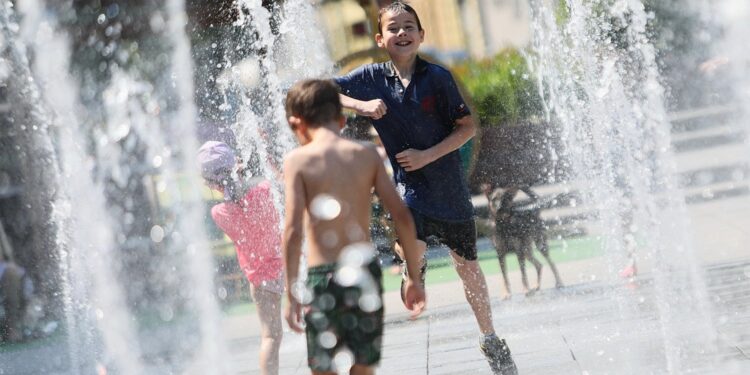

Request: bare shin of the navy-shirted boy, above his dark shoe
left=451, top=251, right=495, bottom=334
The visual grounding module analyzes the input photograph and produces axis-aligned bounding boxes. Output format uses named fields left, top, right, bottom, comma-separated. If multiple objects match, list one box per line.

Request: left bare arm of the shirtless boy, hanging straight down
left=281, top=155, right=305, bottom=332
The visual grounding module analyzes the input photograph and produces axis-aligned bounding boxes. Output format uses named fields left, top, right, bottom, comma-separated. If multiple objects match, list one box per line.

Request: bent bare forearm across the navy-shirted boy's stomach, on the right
left=396, top=115, right=477, bottom=172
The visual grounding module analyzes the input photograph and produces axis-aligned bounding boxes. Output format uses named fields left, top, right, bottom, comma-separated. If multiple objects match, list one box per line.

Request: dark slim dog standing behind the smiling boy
left=483, top=186, right=563, bottom=299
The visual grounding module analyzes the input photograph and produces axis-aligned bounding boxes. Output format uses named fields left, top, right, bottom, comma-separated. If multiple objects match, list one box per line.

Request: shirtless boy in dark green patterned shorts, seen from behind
left=282, top=80, right=425, bottom=374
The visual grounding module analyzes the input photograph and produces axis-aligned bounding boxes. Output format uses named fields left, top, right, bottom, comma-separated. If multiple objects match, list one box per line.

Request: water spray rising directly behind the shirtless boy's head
left=218, top=0, right=333, bottom=219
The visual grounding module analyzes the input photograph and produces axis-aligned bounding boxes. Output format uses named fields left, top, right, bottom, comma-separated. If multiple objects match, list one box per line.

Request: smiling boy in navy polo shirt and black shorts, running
left=336, top=1, right=516, bottom=374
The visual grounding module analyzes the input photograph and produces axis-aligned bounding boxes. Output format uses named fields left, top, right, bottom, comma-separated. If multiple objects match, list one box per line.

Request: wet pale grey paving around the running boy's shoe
left=231, top=260, right=750, bottom=375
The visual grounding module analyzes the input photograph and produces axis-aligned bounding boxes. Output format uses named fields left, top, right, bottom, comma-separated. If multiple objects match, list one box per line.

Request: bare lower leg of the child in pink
left=250, top=286, right=282, bottom=375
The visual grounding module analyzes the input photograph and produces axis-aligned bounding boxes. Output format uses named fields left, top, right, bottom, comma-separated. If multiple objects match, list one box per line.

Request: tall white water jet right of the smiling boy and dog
left=529, top=0, right=715, bottom=373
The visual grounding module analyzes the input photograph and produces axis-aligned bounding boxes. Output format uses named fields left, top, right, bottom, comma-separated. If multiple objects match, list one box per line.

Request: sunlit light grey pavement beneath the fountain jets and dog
left=226, top=198, right=750, bottom=375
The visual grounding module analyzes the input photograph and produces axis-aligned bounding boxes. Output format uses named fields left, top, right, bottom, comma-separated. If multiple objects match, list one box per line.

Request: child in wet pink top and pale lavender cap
left=198, top=141, right=284, bottom=375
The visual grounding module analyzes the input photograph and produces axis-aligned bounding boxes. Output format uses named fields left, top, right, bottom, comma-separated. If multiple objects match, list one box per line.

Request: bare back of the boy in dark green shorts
left=285, top=135, right=388, bottom=267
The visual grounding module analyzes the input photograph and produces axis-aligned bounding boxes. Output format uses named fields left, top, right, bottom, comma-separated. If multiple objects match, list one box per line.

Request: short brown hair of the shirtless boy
left=286, top=79, right=342, bottom=126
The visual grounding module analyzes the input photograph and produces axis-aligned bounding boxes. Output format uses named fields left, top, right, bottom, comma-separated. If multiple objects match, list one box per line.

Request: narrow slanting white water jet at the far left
left=21, top=1, right=148, bottom=374
